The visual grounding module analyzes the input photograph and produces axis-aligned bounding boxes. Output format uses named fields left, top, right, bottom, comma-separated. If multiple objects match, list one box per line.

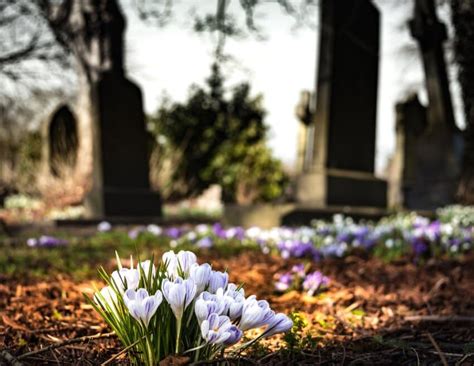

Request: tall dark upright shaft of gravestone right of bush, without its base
left=313, top=0, right=380, bottom=173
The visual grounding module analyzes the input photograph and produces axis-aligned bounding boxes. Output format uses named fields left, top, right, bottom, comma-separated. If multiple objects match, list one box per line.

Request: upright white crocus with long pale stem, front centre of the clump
left=161, top=277, right=196, bottom=320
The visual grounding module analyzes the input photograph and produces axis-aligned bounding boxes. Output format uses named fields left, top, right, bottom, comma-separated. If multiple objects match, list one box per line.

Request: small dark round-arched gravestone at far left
left=46, top=105, right=79, bottom=178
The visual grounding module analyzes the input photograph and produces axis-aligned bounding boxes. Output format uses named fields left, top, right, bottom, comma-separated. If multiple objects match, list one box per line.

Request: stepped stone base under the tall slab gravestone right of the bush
left=296, top=169, right=387, bottom=208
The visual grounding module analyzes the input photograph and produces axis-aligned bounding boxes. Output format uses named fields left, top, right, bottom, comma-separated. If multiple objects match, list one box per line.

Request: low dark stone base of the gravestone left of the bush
left=86, top=190, right=162, bottom=218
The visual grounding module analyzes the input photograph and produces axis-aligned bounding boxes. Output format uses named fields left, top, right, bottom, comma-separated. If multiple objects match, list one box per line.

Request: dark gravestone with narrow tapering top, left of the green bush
left=86, top=1, right=161, bottom=217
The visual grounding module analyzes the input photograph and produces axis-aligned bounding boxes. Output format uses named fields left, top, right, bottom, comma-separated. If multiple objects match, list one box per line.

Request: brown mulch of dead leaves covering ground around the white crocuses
left=0, top=252, right=474, bottom=365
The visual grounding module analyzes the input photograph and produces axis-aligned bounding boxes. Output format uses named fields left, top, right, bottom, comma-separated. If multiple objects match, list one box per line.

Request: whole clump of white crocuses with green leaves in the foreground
left=92, top=251, right=293, bottom=364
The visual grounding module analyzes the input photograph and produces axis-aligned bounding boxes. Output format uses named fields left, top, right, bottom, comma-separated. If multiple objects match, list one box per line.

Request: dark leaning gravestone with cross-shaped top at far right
left=404, top=0, right=463, bottom=209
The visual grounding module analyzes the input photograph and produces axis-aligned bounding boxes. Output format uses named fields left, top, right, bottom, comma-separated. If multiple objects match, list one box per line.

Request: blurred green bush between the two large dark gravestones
left=148, top=64, right=288, bottom=203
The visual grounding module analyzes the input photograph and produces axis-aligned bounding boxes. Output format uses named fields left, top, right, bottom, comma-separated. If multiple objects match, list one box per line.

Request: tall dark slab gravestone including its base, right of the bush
left=296, top=0, right=387, bottom=207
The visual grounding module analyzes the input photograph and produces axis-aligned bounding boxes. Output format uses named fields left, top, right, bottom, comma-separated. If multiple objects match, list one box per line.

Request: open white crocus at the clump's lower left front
left=123, top=288, right=163, bottom=327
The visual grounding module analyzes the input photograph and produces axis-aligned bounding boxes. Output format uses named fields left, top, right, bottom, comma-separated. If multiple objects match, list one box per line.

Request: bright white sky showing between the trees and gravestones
left=121, top=0, right=462, bottom=172
